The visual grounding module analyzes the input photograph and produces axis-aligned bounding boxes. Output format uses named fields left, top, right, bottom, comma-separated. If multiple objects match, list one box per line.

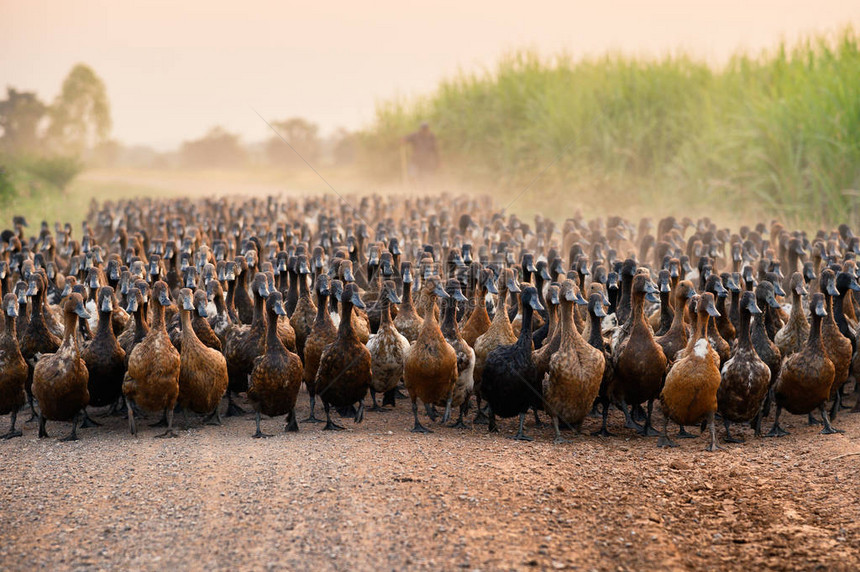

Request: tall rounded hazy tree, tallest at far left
left=48, top=64, right=111, bottom=153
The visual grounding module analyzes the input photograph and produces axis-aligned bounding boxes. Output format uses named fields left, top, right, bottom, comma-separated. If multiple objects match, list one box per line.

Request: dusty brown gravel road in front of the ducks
left=0, top=394, right=860, bottom=570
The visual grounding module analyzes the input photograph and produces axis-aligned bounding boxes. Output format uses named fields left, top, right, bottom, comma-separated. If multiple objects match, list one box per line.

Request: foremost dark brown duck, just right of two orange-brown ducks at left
left=248, top=292, right=304, bottom=439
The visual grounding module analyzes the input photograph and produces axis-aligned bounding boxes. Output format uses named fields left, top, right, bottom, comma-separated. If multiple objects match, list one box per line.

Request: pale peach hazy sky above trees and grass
left=0, top=0, right=860, bottom=149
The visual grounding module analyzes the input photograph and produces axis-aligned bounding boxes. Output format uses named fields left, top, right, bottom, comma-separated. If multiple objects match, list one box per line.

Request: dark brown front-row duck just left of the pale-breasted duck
left=314, top=283, right=372, bottom=431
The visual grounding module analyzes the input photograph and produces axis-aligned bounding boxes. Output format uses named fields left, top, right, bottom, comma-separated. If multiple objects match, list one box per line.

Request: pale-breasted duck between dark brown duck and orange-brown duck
left=367, top=280, right=409, bottom=411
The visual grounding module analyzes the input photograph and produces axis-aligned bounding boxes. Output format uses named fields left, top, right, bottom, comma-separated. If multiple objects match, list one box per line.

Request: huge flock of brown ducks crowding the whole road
left=0, top=196, right=860, bottom=450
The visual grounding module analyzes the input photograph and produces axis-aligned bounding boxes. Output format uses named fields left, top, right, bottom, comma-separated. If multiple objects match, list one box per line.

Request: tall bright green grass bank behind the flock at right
left=361, top=28, right=860, bottom=225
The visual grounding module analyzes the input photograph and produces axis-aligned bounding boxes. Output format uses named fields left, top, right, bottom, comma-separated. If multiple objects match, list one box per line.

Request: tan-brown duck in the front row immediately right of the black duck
left=543, top=280, right=604, bottom=443
